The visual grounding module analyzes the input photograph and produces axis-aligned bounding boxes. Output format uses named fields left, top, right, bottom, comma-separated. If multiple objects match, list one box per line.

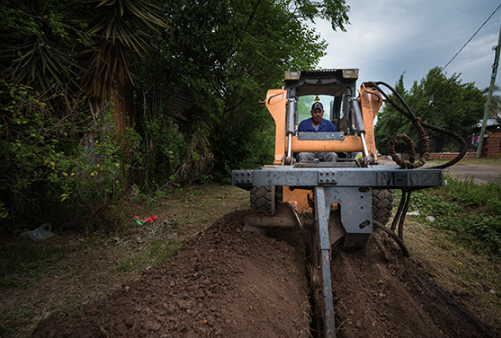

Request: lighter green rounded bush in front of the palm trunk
left=48, top=121, right=142, bottom=222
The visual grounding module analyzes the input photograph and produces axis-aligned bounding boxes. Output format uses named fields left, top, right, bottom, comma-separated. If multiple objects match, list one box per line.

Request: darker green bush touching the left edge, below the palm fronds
left=0, top=82, right=75, bottom=227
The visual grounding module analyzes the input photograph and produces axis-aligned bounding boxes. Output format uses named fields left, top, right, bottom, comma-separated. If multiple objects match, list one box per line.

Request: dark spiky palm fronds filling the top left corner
left=0, top=0, right=81, bottom=91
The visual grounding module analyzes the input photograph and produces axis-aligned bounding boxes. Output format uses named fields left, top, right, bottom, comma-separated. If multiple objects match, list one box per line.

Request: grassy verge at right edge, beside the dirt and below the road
left=405, top=176, right=501, bottom=333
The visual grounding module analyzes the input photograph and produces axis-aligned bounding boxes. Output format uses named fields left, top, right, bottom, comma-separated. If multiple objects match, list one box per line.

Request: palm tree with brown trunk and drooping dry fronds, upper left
left=74, top=0, right=167, bottom=131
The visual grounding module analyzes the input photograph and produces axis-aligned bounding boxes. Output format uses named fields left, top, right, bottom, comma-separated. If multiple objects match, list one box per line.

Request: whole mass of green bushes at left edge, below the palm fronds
left=0, top=82, right=141, bottom=230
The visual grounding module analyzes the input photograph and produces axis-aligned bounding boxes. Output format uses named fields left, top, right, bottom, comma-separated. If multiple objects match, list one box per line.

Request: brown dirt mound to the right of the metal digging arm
left=331, top=233, right=496, bottom=338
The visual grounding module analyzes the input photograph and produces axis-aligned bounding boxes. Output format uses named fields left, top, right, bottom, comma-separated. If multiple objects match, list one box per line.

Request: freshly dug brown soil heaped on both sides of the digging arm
left=32, top=210, right=496, bottom=338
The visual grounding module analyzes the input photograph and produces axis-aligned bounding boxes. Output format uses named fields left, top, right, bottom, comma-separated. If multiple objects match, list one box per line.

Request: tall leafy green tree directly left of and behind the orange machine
left=134, top=0, right=349, bottom=182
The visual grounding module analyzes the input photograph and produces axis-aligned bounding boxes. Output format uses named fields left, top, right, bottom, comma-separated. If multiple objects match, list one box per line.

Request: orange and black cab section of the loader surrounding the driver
left=265, top=69, right=383, bottom=165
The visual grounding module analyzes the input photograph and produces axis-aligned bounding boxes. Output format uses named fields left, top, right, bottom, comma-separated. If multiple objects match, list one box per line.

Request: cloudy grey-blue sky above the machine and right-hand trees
left=315, top=0, right=501, bottom=89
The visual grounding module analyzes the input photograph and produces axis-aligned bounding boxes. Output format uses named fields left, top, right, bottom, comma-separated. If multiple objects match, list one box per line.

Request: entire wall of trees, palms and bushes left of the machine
left=0, top=0, right=349, bottom=231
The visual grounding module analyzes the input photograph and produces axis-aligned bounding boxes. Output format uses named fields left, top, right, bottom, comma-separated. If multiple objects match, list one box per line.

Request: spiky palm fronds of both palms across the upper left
left=0, top=0, right=166, bottom=115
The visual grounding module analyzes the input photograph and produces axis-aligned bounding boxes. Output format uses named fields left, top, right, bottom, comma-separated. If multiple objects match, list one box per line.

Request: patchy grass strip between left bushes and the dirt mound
left=0, top=184, right=249, bottom=338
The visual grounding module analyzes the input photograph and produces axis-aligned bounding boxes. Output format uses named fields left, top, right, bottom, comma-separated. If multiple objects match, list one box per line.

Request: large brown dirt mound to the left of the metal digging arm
left=32, top=212, right=310, bottom=338
